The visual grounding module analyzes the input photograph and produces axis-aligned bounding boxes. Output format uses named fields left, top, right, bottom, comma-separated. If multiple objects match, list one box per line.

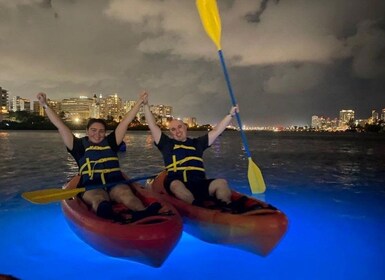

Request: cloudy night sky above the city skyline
left=0, top=0, right=385, bottom=126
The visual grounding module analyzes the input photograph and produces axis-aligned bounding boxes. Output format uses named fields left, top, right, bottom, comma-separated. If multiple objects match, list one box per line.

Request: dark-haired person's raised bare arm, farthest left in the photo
left=36, top=92, right=74, bottom=150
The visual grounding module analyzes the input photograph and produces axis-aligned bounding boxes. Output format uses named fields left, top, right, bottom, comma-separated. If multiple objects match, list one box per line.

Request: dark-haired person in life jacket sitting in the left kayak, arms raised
left=37, top=92, right=161, bottom=222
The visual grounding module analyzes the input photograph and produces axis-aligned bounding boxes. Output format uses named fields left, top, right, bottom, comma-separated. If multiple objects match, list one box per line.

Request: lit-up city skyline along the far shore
left=0, top=87, right=385, bottom=132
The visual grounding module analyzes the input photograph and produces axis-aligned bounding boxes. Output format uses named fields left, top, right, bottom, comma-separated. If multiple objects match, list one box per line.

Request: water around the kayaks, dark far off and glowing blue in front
left=0, top=131, right=385, bottom=280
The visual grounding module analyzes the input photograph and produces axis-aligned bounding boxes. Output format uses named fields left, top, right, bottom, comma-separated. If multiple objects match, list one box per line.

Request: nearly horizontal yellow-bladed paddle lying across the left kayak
left=21, top=175, right=157, bottom=204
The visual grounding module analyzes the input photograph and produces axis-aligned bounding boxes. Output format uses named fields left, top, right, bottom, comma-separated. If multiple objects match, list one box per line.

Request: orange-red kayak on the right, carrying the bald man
left=150, top=172, right=288, bottom=256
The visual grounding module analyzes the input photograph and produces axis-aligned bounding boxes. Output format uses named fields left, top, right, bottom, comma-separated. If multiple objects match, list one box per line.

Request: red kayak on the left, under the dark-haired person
left=61, top=176, right=183, bottom=267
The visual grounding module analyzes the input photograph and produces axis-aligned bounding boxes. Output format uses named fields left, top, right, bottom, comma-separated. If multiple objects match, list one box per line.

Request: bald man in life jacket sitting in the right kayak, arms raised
left=143, top=92, right=238, bottom=205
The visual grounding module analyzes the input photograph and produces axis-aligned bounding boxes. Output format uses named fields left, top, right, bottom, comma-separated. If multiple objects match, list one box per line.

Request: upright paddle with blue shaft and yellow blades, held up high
left=196, top=0, right=266, bottom=193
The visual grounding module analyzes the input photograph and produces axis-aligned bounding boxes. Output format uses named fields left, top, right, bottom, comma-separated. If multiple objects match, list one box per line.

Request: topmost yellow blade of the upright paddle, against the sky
left=196, top=0, right=222, bottom=50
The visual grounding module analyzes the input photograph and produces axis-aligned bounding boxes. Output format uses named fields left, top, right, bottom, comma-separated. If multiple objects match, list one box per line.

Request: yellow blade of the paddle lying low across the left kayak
left=21, top=188, right=86, bottom=204
